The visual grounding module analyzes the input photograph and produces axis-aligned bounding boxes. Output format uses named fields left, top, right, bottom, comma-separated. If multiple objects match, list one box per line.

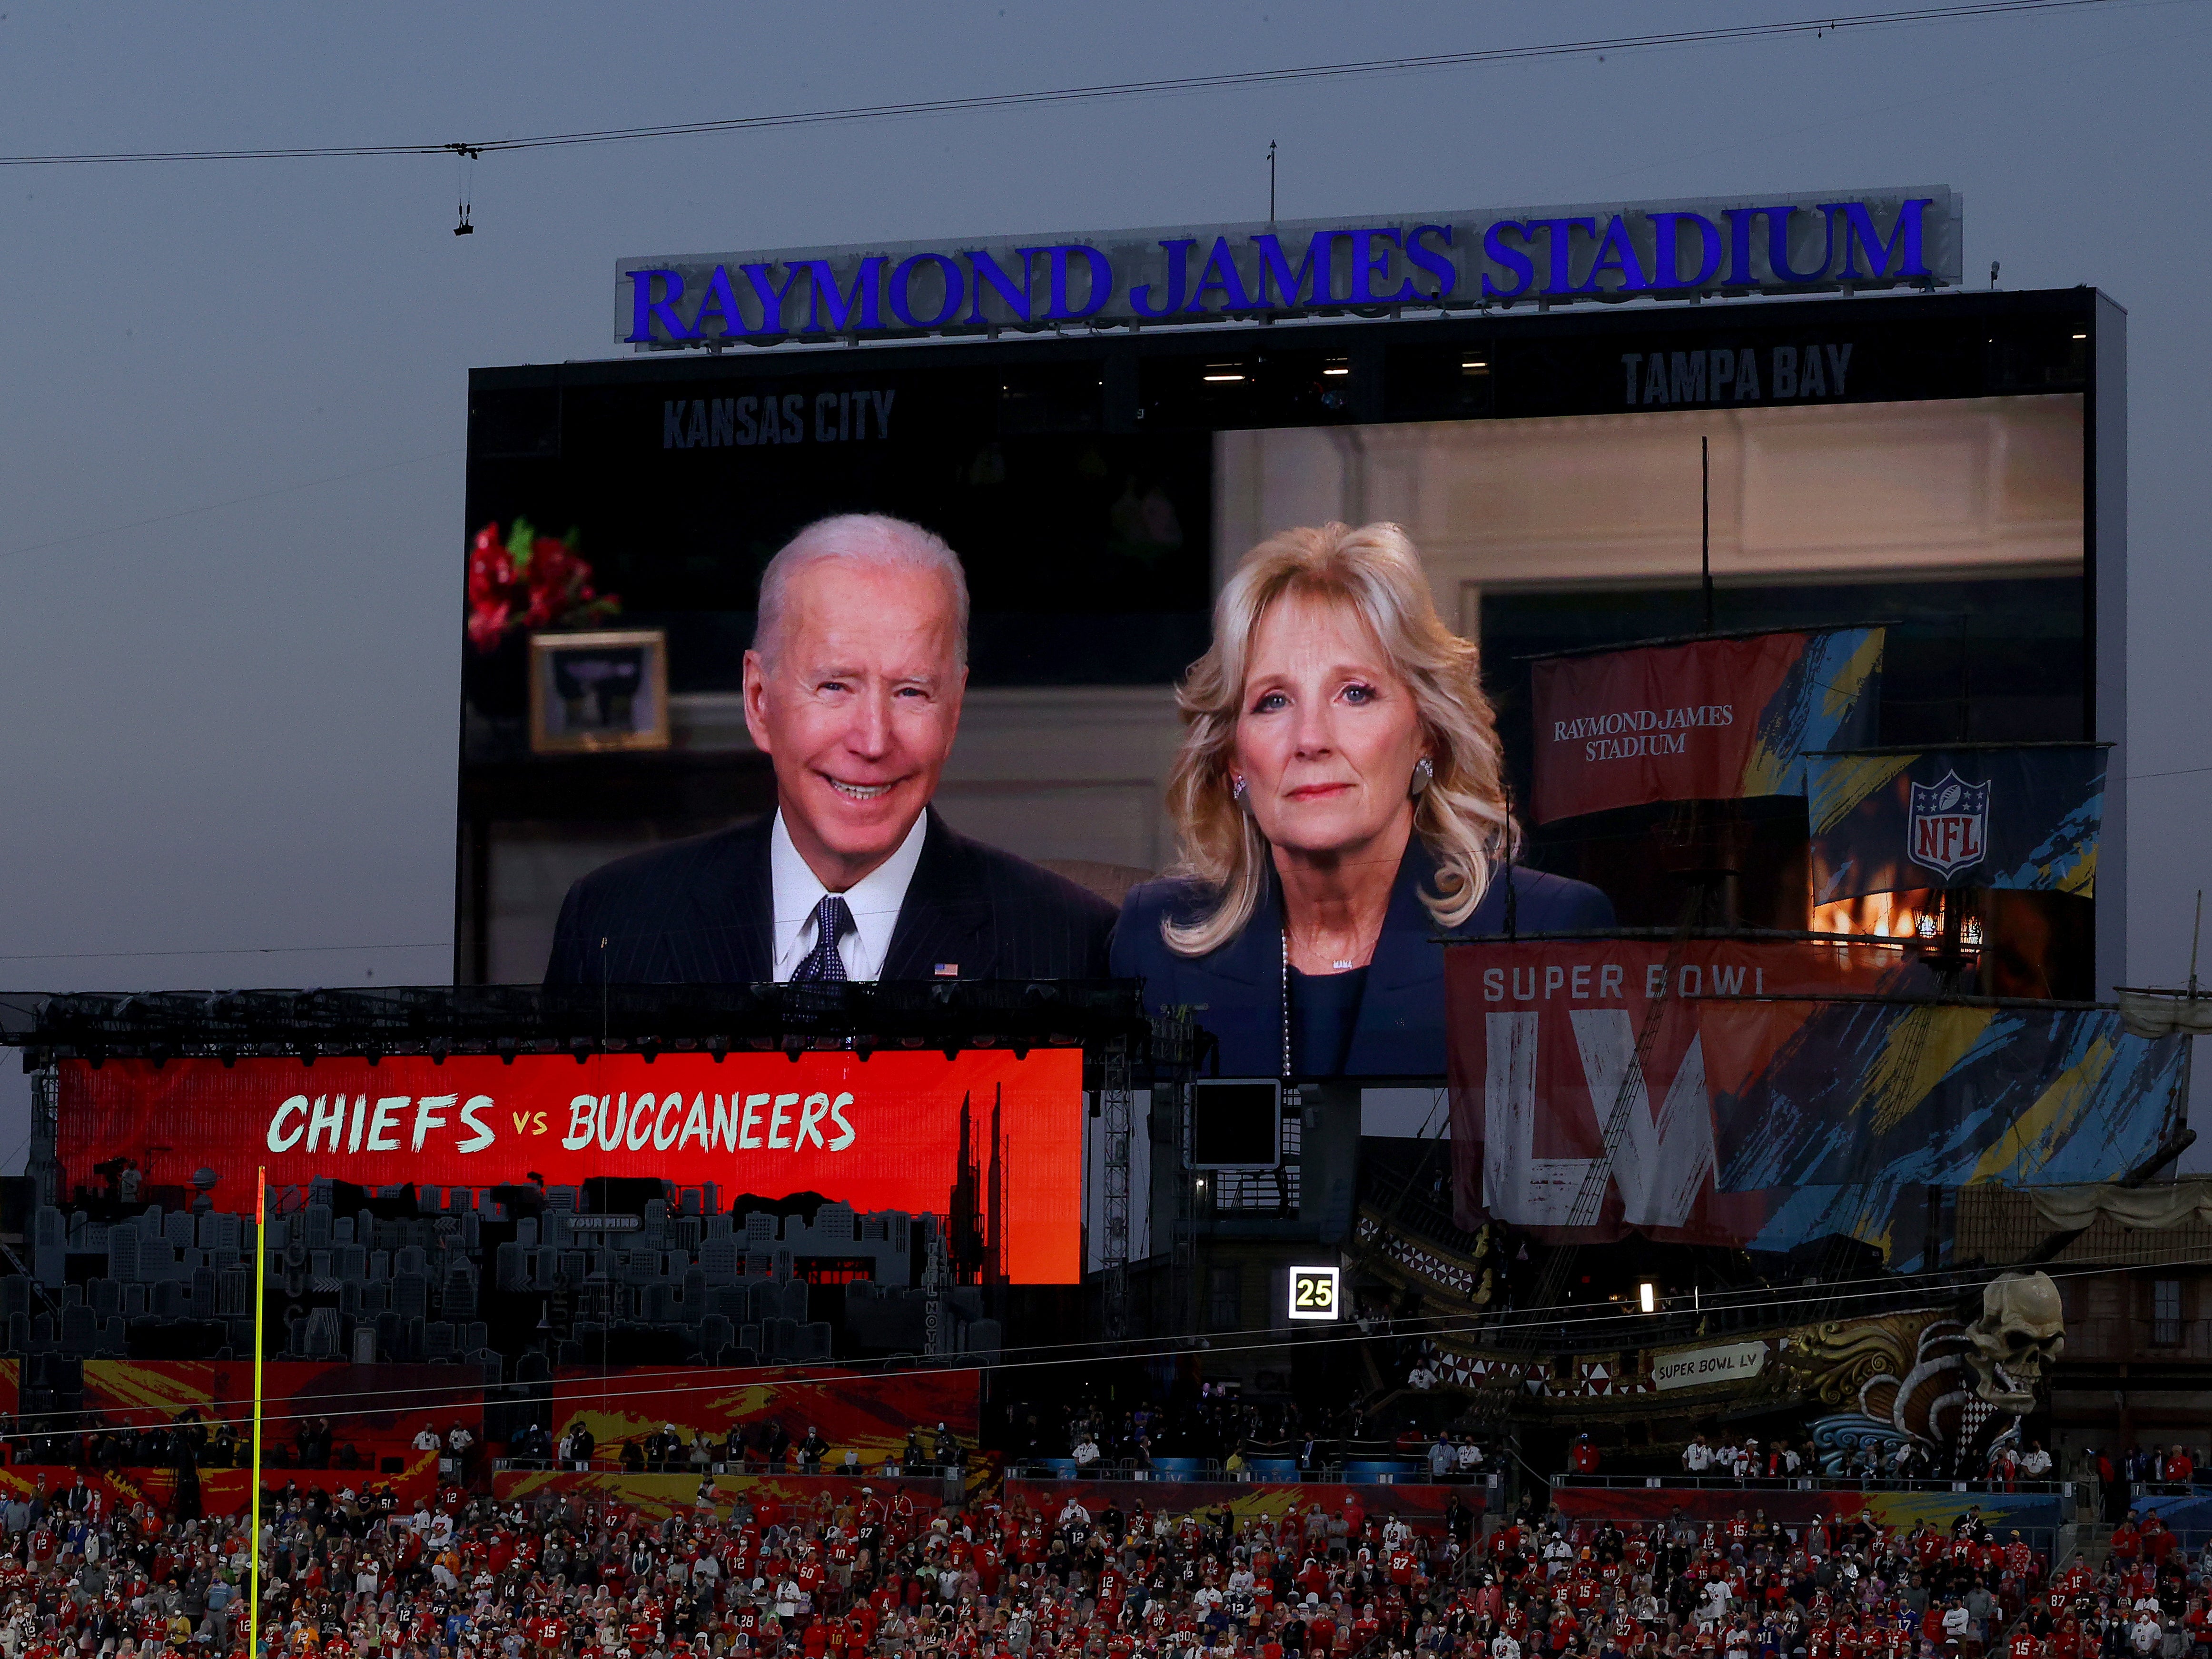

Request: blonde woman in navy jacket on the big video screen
left=1113, top=524, right=1612, bottom=1077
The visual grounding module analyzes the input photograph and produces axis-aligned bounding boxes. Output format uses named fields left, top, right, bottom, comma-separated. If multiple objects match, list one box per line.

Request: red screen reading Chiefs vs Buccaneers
left=58, top=1048, right=1084, bottom=1285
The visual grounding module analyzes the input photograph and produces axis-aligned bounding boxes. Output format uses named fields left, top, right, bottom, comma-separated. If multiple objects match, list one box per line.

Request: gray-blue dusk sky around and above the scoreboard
left=0, top=0, right=2212, bottom=1168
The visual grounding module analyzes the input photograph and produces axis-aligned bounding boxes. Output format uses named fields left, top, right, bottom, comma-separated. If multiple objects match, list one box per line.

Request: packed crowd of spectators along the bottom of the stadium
left=0, top=1433, right=2212, bottom=1659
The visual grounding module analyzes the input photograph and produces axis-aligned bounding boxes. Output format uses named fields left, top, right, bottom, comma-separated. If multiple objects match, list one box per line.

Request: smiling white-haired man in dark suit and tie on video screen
left=546, top=515, right=1115, bottom=984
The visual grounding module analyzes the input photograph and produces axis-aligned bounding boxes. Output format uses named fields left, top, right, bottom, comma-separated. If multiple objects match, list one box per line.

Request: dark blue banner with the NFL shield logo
left=1805, top=743, right=2106, bottom=905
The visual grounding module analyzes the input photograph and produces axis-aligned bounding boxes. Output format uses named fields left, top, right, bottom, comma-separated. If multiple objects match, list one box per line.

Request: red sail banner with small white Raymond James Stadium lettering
left=1533, top=628, right=1882, bottom=823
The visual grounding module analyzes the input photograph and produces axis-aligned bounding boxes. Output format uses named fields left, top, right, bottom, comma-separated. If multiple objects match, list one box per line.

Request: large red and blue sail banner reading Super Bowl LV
left=1444, top=940, right=2181, bottom=1252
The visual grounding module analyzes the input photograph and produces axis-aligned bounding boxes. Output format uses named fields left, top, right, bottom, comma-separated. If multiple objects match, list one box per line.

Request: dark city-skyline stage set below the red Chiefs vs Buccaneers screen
left=0, top=1181, right=1000, bottom=1382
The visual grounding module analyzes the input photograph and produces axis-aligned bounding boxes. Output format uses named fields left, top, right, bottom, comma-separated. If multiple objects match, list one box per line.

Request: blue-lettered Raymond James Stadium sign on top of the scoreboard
left=615, top=186, right=1962, bottom=352
